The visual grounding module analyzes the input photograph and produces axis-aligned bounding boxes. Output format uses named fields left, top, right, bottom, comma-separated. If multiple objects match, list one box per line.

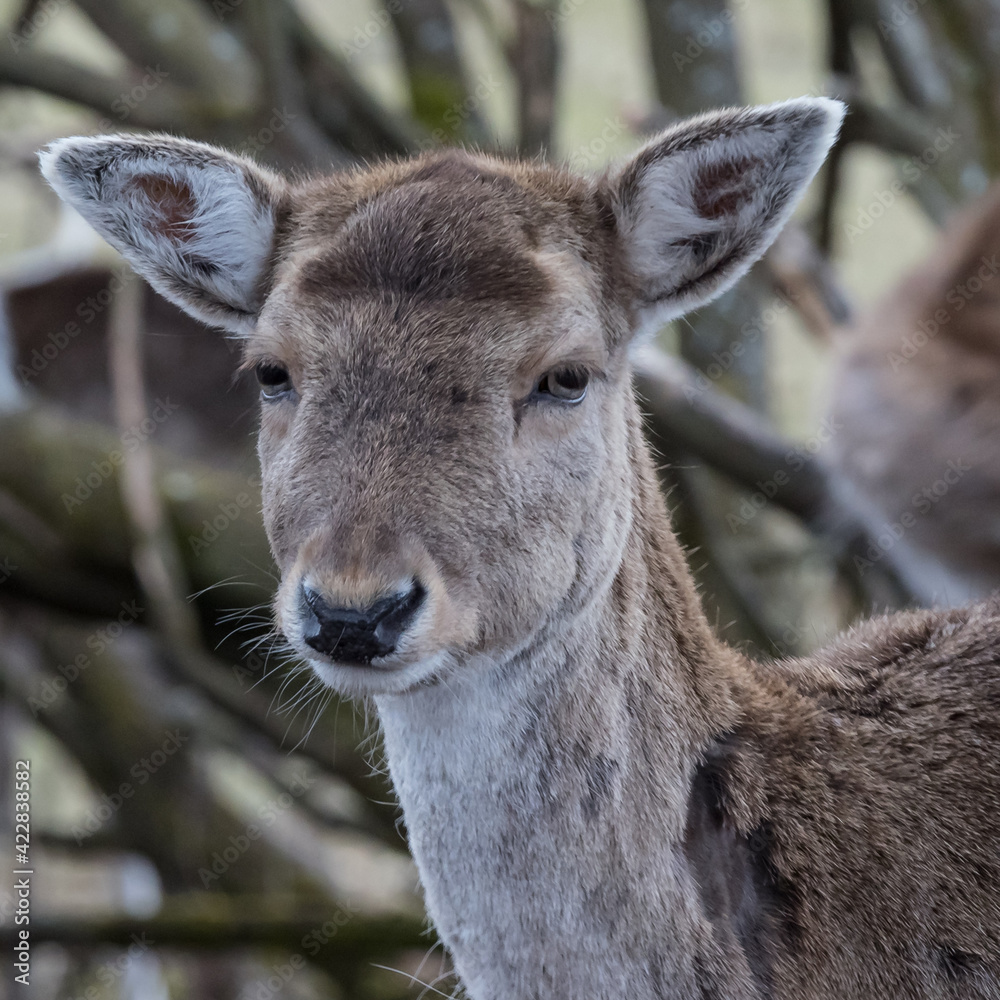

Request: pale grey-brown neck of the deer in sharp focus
left=377, top=408, right=736, bottom=1000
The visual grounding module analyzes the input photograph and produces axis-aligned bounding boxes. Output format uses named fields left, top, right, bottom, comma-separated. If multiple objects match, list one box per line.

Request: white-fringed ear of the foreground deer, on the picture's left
left=39, top=136, right=284, bottom=333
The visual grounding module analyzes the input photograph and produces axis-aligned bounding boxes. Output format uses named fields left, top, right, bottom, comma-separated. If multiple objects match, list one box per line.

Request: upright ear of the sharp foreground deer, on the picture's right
left=610, top=98, right=844, bottom=325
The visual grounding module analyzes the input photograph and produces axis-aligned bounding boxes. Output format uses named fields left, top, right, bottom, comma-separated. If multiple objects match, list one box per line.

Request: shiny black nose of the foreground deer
left=302, top=580, right=425, bottom=663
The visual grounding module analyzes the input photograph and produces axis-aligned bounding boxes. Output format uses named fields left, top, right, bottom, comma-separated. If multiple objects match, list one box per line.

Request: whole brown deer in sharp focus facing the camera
left=41, top=98, right=1000, bottom=1000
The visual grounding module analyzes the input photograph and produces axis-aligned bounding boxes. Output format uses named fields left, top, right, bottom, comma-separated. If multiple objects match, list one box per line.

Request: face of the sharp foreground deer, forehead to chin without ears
left=246, top=166, right=628, bottom=696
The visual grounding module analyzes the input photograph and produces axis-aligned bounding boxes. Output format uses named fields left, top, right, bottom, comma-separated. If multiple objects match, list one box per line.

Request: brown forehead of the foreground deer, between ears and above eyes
left=247, top=157, right=610, bottom=377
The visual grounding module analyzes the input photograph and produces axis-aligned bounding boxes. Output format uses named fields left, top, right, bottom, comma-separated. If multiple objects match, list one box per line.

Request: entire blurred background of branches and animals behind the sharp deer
left=0, top=0, right=1000, bottom=1000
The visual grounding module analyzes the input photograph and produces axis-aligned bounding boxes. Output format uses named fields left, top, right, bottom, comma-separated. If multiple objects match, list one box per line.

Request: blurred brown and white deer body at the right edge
left=829, top=185, right=1000, bottom=605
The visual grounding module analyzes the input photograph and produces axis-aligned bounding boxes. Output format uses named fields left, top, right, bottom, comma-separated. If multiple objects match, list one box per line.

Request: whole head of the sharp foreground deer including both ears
left=43, top=100, right=842, bottom=694
